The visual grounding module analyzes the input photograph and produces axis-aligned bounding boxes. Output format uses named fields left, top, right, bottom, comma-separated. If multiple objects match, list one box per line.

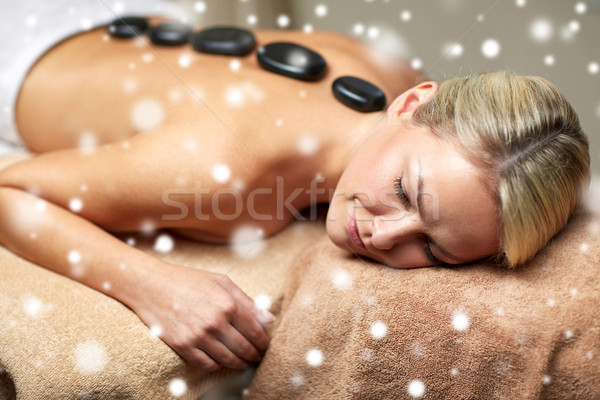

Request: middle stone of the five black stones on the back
left=192, top=27, right=256, bottom=56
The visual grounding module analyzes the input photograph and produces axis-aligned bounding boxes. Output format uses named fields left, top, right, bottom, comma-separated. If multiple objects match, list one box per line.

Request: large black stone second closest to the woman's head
left=256, top=42, right=327, bottom=81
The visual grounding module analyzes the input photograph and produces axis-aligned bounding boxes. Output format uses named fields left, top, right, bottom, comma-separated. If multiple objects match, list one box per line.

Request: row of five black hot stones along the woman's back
left=107, top=17, right=386, bottom=112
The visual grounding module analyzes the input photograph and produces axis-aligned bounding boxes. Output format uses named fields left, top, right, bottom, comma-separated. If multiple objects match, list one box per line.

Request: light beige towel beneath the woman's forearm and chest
left=0, top=152, right=324, bottom=400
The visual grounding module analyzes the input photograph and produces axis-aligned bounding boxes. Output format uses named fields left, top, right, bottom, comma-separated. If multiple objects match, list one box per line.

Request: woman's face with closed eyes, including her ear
left=327, top=82, right=500, bottom=268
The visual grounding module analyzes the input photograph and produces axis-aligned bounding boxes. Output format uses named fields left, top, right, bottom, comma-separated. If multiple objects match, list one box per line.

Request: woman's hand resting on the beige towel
left=130, top=264, right=275, bottom=371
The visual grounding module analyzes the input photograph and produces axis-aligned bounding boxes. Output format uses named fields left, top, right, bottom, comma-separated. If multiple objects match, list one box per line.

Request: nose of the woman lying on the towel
left=371, top=214, right=420, bottom=250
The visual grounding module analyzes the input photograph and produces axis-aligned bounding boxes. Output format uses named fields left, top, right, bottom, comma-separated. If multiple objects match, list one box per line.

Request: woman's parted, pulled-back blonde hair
left=412, top=71, right=590, bottom=267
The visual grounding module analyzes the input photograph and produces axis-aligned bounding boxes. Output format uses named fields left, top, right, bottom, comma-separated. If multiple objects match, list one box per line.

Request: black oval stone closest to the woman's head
left=331, top=76, right=385, bottom=112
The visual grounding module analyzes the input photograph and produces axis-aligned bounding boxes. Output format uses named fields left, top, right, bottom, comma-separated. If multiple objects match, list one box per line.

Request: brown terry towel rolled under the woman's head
left=245, top=199, right=600, bottom=400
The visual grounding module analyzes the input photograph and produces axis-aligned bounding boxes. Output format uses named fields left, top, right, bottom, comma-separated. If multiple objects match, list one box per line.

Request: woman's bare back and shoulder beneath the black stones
left=9, top=21, right=419, bottom=242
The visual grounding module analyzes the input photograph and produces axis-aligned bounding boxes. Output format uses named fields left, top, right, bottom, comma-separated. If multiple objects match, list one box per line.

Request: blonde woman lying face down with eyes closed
left=0, top=15, right=589, bottom=370
